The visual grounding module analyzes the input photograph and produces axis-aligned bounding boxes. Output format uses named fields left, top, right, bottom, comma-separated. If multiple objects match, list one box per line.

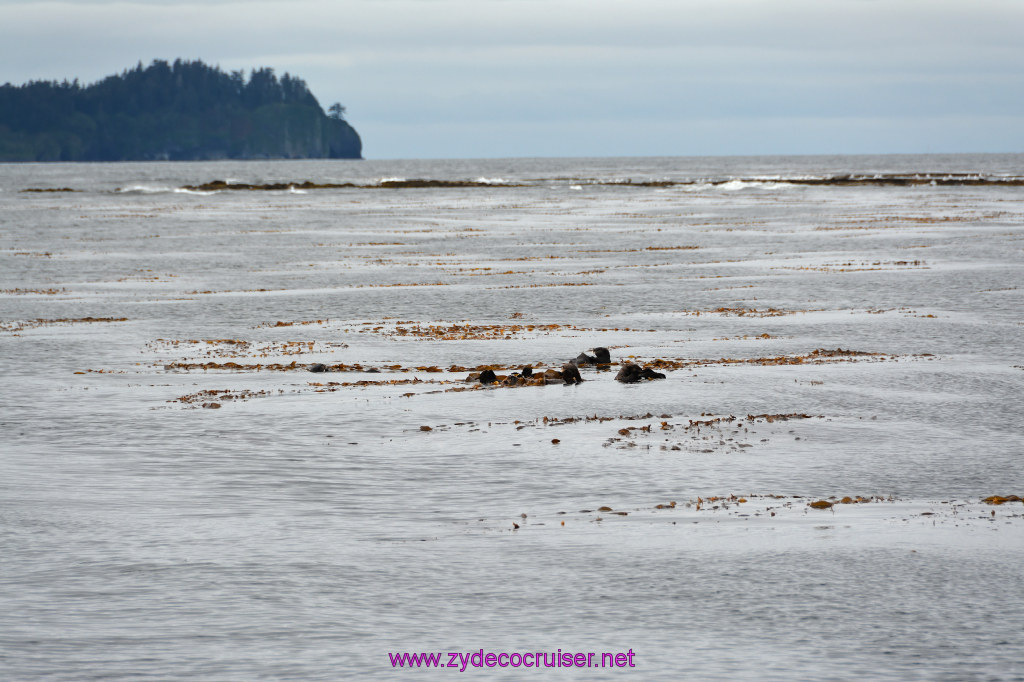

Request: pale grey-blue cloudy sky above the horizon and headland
left=0, top=0, right=1024, bottom=159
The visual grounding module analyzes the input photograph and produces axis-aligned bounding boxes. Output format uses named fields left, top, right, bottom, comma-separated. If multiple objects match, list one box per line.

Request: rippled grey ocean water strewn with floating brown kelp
left=0, top=155, right=1024, bottom=680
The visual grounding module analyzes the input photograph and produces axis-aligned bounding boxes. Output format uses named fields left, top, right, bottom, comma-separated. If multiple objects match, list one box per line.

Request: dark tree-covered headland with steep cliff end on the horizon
left=0, top=59, right=362, bottom=162
